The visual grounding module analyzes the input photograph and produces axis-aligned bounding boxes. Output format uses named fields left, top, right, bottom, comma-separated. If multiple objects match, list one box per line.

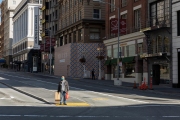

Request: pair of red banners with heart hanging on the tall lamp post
left=110, top=18, right=126, bottom=35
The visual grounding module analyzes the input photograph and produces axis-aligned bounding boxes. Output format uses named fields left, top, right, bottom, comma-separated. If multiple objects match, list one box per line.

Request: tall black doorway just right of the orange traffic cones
left=152, top=64, right=160, bottom=85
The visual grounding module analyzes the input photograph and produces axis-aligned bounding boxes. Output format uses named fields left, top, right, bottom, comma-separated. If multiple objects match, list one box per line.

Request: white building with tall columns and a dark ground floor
left=12, top=0, right=42, bottom=72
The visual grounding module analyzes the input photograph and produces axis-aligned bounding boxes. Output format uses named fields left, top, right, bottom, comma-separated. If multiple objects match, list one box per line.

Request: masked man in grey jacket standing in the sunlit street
left=58, top=76, right=69, bottom=105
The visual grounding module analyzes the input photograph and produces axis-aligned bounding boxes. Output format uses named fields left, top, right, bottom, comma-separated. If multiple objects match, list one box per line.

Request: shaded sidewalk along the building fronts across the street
left=0, top=69, right=180, bottom=97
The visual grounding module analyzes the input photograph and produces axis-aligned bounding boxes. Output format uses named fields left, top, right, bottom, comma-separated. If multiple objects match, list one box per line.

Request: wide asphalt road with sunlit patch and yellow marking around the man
left=0, top=70, right=180, bottom=120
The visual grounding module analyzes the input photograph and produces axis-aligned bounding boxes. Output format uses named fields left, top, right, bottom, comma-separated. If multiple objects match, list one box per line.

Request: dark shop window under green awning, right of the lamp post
left=124, top=63, right=136, bottom=78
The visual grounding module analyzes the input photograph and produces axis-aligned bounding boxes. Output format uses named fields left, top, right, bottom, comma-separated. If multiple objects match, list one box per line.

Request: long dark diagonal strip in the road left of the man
left=0, top=82, right=51, bottom=104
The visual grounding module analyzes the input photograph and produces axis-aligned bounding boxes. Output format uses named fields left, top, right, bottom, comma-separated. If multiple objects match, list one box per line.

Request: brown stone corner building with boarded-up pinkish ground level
left=54, top=0, right=105, bottom=78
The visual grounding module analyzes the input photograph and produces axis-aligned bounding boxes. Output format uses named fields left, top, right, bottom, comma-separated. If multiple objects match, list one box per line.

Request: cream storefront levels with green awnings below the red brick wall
left=104, top=32, right=145, bottom=83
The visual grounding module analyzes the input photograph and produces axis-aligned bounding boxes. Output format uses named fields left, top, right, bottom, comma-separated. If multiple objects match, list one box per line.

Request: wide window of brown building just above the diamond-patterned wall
left=89, top=29, right=100, bottom=40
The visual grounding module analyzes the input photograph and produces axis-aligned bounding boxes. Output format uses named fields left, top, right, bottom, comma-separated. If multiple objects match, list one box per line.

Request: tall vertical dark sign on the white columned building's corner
left=33, top=7, right=40, bottom=50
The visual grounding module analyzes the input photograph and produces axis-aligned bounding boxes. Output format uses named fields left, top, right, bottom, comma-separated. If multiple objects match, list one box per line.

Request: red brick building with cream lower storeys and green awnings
left=102, top=0, right=148, bottom=83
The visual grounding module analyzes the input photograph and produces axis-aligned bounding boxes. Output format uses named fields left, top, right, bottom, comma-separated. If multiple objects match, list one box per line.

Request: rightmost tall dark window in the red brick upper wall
left=134, top=9, right=141, bottom=31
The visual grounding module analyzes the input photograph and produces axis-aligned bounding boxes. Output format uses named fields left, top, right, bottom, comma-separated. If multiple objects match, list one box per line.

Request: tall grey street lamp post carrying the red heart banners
left=99, top=0, right=122, bottom=85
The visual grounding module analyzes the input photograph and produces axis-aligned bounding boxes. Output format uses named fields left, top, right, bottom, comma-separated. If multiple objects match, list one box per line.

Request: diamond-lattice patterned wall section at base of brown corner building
left=70, top=43, right=105, bottom=78
